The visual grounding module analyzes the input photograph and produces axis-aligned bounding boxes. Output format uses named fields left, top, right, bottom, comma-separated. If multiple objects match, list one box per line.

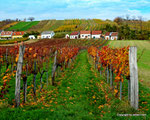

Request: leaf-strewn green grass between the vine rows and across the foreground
left=0, top=51, right=150, bottom=120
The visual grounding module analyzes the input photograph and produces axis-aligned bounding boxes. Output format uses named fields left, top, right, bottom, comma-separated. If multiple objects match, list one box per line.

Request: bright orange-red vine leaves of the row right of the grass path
left=88, top=46, right=129, bottom=82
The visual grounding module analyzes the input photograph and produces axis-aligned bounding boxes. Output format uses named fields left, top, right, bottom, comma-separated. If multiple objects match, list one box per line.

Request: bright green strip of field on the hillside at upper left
left=7, top=21, right=39, bottom=31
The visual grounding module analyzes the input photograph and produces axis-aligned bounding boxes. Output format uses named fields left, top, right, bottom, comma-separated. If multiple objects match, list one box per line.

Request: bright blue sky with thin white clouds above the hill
left=0, top=0, right=150, bottom=20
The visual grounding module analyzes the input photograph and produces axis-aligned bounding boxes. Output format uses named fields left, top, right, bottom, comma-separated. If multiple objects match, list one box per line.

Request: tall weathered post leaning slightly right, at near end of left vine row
left=15, top=45, right=25, bottom=107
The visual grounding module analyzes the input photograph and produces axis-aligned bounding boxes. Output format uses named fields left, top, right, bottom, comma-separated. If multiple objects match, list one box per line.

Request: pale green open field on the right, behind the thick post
left=109, top=40, right=150, bottom=87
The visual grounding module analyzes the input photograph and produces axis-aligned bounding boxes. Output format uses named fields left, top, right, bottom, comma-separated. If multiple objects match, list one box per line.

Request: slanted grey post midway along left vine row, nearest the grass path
left=52, top=50, right=57, bottom=85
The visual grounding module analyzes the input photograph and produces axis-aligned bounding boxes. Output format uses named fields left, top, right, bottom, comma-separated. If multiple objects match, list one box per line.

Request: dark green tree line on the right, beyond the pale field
left=113, top=15, right=150, bottom=40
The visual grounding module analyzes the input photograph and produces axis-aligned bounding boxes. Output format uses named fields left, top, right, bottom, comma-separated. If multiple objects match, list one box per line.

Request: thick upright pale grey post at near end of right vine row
left=129, top=47, right=139, bottom=110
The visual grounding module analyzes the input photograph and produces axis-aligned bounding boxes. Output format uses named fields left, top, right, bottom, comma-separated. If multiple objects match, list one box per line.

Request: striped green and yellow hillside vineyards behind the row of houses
left=0, top=19, right=116, bottom=32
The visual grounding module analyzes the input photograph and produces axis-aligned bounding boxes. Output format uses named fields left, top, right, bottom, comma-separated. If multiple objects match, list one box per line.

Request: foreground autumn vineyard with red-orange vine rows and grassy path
left=0, top=39, right=150, bottom=120
